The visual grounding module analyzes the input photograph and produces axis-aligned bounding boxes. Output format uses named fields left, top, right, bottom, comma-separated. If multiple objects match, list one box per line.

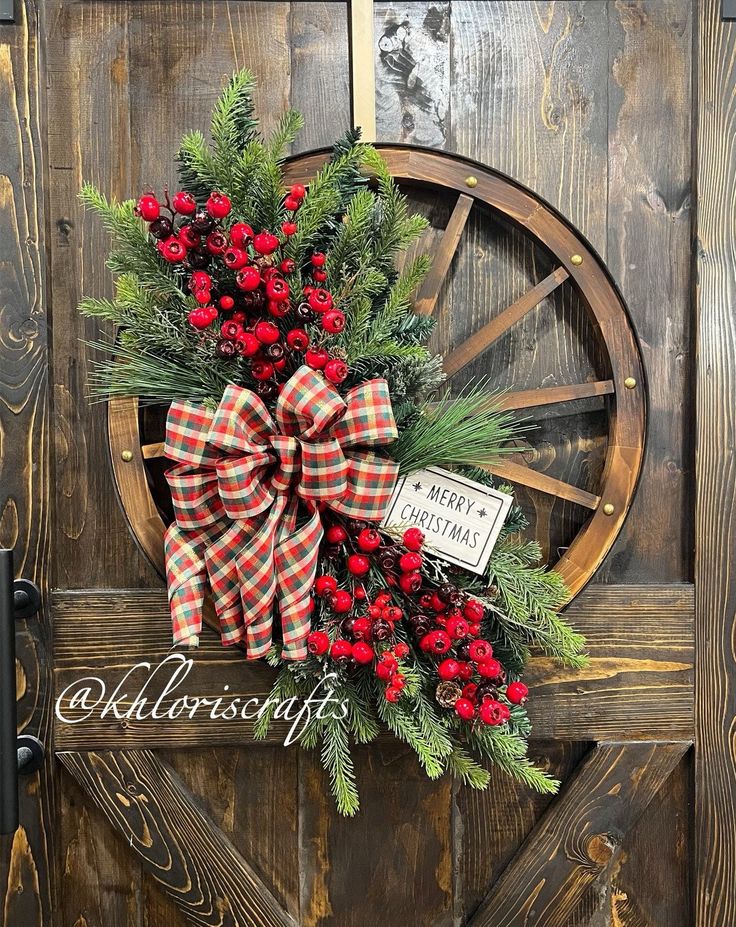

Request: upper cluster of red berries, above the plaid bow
left=136, top=184, right=349, bottom=397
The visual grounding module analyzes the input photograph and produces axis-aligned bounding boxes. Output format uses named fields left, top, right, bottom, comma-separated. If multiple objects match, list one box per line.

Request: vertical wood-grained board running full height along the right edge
left=694, top=0, right=736, bottom=927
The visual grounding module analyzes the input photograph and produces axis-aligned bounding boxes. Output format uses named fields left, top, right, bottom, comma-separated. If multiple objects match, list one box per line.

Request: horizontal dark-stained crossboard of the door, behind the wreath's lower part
left=53, top=586, right=693, bottom=749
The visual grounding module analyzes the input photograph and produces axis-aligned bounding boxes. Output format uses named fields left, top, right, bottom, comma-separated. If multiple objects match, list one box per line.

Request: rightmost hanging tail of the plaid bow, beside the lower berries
left=274, top=500, right=324, bottom=660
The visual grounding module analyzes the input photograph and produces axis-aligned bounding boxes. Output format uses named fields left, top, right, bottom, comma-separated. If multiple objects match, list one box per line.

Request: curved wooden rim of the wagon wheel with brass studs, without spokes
left=108, top=145, right=646, bottom=599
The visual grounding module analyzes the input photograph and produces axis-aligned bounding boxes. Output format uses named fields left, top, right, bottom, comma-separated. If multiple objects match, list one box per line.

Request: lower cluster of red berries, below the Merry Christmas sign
left=308, top=522, right=528, bottom=725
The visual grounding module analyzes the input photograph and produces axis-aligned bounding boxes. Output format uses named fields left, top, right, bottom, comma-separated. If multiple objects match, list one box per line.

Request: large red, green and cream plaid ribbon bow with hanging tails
left=165, top=367, right=398, bottom=660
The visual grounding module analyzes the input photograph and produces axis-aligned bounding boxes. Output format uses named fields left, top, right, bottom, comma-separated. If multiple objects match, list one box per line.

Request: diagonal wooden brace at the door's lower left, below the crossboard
left=57, top=750, right=295, bottom=927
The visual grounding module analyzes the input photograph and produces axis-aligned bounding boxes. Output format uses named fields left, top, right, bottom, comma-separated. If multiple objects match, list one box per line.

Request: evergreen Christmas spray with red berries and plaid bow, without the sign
left=80, top=71, right=584, bottom=814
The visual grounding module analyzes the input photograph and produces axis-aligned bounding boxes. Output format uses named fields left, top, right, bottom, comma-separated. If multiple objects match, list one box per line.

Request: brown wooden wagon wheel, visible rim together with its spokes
left=108, top=146, right=646, bottom=597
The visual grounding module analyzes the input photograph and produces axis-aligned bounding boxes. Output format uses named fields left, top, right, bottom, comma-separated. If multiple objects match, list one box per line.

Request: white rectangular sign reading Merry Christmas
left=383, top=467, right=513, bottom=573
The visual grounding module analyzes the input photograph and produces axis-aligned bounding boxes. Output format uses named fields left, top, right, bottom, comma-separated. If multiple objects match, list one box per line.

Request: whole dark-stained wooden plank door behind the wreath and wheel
left=0, top=0, right=736, bottom=927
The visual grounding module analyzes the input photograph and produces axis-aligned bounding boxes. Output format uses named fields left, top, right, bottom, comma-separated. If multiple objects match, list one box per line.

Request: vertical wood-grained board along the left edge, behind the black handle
left=0, top=0, right=56, bottom=927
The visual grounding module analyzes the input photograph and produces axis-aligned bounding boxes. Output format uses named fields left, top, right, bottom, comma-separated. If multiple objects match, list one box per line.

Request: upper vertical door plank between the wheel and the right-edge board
left=600, top=0, right=697, bottom=582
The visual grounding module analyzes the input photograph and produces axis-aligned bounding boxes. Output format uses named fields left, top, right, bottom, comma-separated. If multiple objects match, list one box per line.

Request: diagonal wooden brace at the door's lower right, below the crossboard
left=468, top=741, right=690, bottom=927
